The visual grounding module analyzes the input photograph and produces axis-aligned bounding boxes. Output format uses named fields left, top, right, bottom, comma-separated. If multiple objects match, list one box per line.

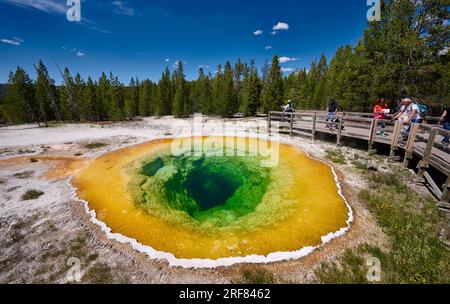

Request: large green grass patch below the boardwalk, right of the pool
left=316, top=173, right=450, bottom=284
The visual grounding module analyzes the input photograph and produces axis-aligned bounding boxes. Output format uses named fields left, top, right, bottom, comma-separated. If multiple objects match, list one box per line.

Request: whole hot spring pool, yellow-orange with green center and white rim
left=72, top=138, right=352, bottom=267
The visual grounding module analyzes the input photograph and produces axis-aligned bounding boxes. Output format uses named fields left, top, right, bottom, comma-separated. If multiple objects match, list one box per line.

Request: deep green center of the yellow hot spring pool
left=131, top=156, right=270, bottom=227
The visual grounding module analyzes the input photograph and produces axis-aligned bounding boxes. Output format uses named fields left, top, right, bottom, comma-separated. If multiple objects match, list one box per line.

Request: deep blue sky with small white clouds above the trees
left=0, top=0, right=369, bottom=83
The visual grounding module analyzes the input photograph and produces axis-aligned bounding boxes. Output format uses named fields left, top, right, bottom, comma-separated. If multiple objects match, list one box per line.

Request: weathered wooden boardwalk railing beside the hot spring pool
left=268, top=111, right=450, bottom=205
